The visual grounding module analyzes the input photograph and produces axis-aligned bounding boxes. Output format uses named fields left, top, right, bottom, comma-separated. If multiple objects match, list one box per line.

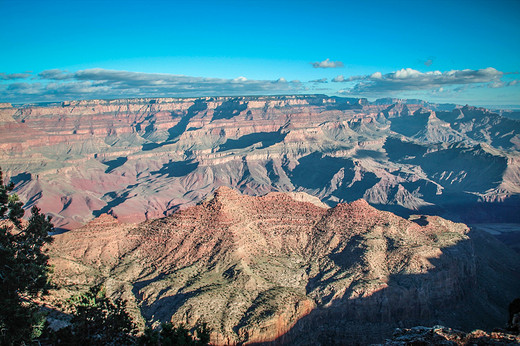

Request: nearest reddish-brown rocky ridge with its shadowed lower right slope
left=46, top=187, right=520, bottom=344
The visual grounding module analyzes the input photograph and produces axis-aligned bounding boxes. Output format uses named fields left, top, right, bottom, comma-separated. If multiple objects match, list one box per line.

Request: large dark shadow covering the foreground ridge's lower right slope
left=250, top=231, right=520, bottom=345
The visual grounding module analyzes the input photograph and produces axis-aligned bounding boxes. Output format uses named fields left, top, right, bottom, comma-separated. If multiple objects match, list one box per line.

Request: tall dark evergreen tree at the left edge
left=0, top=169, right=53, bottom=345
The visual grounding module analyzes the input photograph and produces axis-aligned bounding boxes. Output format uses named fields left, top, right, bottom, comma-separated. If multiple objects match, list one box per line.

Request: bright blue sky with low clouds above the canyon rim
left=0, top=0, right=520, bottom=106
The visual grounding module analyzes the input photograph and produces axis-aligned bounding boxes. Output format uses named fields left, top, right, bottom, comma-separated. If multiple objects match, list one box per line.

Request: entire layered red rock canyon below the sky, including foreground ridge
left=0, top=95, right=520, bottom=345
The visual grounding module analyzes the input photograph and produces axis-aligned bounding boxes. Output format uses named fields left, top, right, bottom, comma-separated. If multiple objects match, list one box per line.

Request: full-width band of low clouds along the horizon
left=0, top=66, right=520, bottom=103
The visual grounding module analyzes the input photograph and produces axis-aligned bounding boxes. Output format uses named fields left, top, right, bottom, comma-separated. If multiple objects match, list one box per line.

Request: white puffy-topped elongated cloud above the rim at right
left=333, top=67, right=514, bottom=94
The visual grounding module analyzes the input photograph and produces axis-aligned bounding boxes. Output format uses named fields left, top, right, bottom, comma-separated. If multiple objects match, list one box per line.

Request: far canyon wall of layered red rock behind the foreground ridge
left=0, top=95, right=520, bottom=229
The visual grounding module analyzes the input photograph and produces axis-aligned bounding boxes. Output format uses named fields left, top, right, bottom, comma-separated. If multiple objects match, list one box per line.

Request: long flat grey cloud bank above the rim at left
left=0, top=68, right=301, bottom=102
